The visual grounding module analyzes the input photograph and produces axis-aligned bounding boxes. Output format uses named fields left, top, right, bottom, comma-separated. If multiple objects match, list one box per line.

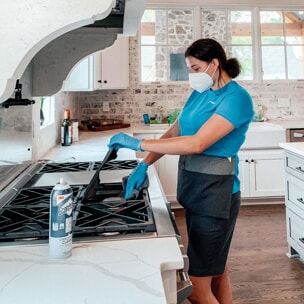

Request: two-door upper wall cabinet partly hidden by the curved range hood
left=62, top=36, right=129, bottom=91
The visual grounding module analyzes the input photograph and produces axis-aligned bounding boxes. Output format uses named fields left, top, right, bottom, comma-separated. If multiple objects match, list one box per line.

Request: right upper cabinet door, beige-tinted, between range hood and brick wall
left=94, top=36, right=129, bottom=90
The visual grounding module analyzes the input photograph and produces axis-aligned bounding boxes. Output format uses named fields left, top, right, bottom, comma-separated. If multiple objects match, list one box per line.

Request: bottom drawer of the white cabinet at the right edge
left=286, top=208, right=304, bottom=258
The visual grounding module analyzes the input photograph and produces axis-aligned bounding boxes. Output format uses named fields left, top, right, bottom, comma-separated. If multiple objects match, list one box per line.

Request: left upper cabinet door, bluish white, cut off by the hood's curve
left=62, top=55, right=94, bottom=91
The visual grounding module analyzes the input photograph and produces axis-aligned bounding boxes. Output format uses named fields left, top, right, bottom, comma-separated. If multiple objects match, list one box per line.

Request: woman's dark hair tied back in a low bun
left=185, top=38, right=241, bottom=78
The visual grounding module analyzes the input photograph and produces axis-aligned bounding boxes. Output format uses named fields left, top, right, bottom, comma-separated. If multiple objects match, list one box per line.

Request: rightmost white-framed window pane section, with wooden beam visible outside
left=260, top=11, right=304, bottom=79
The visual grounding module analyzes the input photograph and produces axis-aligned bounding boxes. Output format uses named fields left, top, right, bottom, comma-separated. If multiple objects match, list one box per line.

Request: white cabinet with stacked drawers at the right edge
left=285, top=152, right=304, bottom=259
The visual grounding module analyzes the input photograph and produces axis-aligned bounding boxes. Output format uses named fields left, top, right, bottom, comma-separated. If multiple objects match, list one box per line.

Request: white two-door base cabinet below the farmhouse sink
left=239, top=149, right=285, bottom=198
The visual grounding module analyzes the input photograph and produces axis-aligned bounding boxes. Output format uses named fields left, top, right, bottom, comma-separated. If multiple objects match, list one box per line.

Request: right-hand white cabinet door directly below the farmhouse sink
left=248, top=150, right=285, bottom=197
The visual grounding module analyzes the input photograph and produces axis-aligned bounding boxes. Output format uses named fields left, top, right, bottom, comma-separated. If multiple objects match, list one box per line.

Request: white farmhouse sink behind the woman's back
left=241, top=122, right=286, bottom=149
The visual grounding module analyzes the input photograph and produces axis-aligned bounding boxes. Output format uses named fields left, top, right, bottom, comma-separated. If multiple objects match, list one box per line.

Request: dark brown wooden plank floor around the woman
left=174, top=204, right=304, bottom=304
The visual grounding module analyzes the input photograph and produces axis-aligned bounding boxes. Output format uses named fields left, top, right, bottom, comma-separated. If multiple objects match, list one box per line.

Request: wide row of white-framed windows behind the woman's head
left=140, top=7, right=304, bottom=82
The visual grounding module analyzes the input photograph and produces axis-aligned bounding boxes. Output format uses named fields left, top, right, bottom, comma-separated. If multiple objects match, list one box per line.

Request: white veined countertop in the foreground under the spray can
left=0, top=238, right=182, bottom=304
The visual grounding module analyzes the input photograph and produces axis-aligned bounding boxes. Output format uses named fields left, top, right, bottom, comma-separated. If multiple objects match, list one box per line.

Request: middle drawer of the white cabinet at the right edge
left=286, top=174, right=304, bottom=213
